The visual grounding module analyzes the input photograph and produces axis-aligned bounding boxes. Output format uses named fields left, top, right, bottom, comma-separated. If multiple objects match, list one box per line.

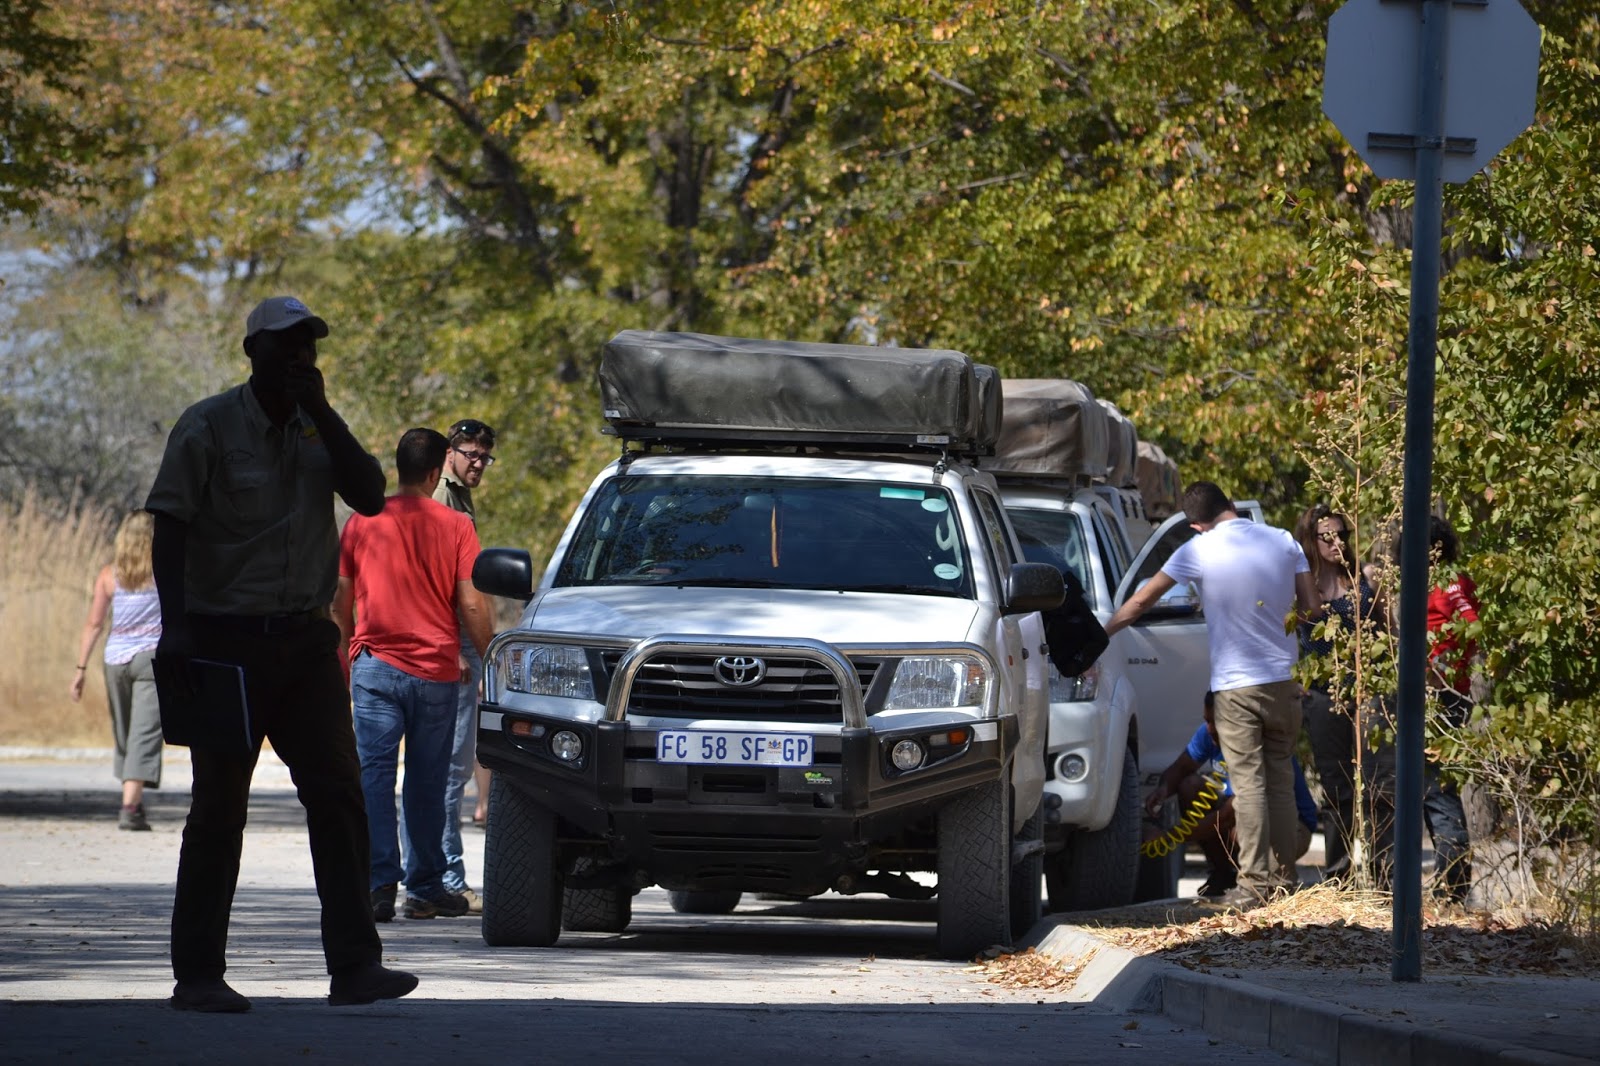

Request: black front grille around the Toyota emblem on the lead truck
left=600, top=651, right=882, bottom=722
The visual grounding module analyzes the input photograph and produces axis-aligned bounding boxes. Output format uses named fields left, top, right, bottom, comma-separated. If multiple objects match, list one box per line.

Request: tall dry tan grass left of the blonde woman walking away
left=0, top=493, right=117, bottom=747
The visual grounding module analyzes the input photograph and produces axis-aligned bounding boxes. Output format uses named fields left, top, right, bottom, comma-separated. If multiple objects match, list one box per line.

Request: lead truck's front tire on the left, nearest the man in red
left=483, top=773, right=562, bottom=948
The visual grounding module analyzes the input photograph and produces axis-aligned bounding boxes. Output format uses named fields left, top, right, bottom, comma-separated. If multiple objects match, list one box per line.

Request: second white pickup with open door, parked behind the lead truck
left=984, top=379, right=1259, bottom=911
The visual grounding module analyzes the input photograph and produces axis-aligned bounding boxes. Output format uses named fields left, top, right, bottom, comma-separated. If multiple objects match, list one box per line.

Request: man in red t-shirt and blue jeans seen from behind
left=333, top=429, right=491, bottom=922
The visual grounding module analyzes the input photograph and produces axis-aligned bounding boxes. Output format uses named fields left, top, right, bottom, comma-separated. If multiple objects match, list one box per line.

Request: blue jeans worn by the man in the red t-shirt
left=350, top=651, right=456, bottom=900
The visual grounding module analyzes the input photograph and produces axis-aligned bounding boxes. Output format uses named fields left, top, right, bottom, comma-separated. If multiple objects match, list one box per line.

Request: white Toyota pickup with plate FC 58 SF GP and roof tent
left=474, top=331, right=1062, bottom=959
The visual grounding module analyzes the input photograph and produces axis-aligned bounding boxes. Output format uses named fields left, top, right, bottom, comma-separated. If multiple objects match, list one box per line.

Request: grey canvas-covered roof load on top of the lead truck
left=600, top=330, right=1002, bottom=455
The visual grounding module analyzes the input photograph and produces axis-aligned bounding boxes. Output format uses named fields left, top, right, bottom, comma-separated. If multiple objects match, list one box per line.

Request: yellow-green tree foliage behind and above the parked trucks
left=6, top=0, right=1600, bottom=838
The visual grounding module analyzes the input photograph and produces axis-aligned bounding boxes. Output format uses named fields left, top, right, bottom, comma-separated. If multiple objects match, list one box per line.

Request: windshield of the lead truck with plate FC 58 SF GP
left=555, top=475, right=973, bottom=599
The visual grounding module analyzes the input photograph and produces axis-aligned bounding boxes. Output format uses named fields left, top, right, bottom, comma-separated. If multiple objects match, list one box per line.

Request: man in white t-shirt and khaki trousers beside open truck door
left=1106, top=482, right=1322, bottom=906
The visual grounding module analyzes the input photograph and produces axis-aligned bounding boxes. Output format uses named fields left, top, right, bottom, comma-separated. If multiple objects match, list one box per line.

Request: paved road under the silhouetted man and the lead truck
left=0, top=760, right=1285, bottom=1066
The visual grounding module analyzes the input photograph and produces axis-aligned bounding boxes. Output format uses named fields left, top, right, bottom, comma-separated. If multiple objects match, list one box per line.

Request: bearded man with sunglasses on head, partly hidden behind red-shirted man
left=434, top=418, right=494, bottom=914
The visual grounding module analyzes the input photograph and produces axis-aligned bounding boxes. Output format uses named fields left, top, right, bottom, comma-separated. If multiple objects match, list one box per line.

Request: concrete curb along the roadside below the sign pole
left=1035, top=919, right=1594, bottom=1066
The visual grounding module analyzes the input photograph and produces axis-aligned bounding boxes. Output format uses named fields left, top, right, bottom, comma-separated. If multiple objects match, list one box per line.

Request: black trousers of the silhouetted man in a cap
left=173, top=621, right=382, bottom=981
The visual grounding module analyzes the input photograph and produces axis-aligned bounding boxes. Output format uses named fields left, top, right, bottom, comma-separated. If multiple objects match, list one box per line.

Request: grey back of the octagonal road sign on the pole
left=1322, top=0, right=1539, bottom=182
